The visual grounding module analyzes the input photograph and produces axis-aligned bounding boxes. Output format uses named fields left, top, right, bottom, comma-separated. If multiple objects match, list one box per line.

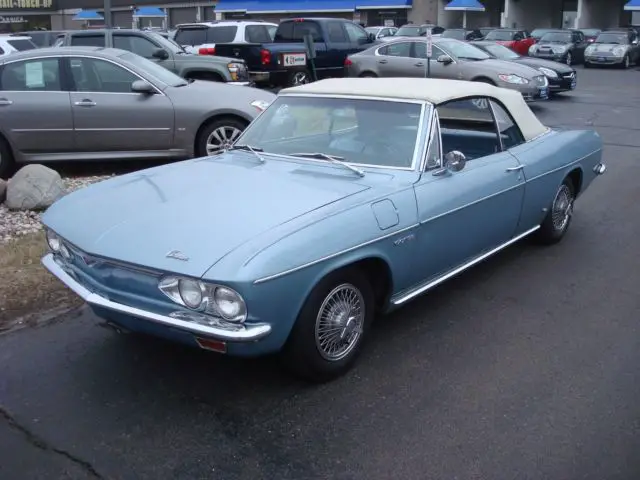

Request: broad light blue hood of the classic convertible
left=42, top=156, right=369, bottom=277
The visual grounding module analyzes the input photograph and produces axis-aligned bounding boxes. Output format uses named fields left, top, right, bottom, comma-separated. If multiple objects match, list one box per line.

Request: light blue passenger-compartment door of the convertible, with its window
left=414, top=97, right=525, bottom=278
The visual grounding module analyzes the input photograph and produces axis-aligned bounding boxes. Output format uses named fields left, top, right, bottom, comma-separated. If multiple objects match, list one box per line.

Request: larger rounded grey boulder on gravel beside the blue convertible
left=6, top=165, right=65, bottom=210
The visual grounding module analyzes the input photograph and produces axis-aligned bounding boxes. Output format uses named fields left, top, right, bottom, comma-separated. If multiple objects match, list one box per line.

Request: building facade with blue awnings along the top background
left=0, top=0, right=640, bottom=33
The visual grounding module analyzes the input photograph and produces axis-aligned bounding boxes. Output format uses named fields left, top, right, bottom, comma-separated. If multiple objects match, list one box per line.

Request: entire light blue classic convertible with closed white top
left=43, top=78, right=605, bottom=381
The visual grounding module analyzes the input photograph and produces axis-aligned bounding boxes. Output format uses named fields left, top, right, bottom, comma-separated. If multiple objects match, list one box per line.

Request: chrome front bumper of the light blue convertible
left=42, top=253, right=271, bottom=342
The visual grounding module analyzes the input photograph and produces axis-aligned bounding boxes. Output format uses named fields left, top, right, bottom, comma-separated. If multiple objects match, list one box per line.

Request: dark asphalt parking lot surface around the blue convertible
left=0, top=68, right=640, bottom=480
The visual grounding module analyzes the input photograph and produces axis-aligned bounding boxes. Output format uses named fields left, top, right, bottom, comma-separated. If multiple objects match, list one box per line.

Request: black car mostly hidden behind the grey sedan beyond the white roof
left=472, top=41, right=577, bottom=93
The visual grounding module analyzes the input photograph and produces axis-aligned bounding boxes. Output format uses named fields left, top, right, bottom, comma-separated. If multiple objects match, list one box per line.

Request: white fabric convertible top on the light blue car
left=280, top=77, right=548, bottom=140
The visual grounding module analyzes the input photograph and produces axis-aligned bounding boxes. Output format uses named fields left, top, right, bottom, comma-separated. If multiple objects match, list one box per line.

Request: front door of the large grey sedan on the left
left=68, top=56, right=174, bottom=156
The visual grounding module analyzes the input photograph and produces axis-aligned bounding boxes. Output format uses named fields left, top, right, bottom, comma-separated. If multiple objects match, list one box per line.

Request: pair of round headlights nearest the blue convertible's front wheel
left=158, top=276, right=247, bottom=323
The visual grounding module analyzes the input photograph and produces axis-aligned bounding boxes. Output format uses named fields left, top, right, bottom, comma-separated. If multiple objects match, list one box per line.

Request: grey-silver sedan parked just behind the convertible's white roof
left=345, top=37, right=549, bottom=101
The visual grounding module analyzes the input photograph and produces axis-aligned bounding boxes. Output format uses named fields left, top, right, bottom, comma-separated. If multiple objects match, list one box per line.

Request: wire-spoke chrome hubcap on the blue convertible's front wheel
left=315, top=283, right=365, bottom=362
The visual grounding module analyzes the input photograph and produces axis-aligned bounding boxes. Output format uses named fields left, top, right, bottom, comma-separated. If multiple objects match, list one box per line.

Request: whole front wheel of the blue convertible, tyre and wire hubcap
left=282, top=269, right=374, bottom=382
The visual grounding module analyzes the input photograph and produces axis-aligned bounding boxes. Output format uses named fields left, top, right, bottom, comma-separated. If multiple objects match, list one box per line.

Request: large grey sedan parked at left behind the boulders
left=0, top=47, right=275, bottom=176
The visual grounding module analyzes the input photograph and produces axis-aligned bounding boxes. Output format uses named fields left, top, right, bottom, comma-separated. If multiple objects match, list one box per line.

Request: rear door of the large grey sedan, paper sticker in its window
left=0, top=57, right=74, bottom=155
